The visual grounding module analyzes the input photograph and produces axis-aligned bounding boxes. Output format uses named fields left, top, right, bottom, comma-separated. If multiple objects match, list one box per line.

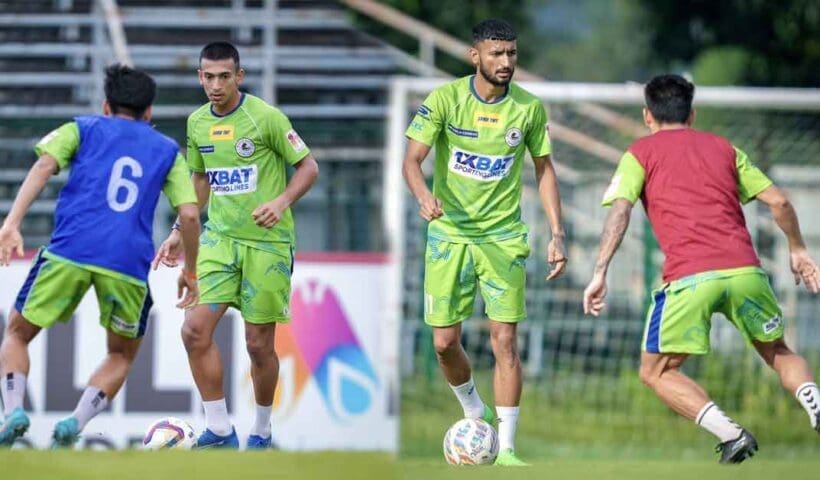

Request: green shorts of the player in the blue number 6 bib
left=14, top=249, right=154, bottom=338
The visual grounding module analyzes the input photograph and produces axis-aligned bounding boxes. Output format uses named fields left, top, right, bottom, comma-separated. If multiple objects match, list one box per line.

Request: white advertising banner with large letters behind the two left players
left=0, top=255, right=398, bottom=451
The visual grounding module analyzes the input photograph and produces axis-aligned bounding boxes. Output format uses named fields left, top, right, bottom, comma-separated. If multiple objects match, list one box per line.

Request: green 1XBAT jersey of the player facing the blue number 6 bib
left=187, top=93, right=310, bottom=250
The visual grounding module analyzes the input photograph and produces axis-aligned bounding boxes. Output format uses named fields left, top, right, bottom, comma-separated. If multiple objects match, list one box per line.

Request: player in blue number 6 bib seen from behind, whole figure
left=0, top=65, right=199, bottom=447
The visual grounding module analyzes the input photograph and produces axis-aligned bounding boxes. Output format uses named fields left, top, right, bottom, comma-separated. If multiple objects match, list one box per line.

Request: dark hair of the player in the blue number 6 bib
left=103, top=63, right=157, bottom=119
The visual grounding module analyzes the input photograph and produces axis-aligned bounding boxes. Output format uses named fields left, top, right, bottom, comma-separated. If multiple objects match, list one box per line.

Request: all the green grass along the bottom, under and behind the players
left=6, top=364, right=820, bottom=480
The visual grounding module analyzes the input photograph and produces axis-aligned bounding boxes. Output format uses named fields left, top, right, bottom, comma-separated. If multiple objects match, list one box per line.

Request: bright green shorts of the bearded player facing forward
left=424, top=235, right=530, bottom=327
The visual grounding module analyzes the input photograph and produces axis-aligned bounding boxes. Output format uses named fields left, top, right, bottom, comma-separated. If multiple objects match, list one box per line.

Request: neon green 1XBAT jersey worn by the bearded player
left=406, top=76, right=551, bottom=243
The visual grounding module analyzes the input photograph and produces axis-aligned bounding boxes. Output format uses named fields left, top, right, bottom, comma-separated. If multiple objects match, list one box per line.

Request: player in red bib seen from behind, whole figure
left=584, top=75, right=820, bottom=463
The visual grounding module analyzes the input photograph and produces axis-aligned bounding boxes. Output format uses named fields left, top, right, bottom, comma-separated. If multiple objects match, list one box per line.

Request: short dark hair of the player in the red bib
left=644, top=75, right=695, bottom=123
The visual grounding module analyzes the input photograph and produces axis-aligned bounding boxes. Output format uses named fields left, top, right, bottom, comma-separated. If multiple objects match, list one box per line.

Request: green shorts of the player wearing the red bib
left=643, top=267, right=783, bottom=355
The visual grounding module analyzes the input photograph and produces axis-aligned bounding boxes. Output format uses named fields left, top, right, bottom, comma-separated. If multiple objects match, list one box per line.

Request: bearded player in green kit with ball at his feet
left=404, top=19, right=567, bottom=465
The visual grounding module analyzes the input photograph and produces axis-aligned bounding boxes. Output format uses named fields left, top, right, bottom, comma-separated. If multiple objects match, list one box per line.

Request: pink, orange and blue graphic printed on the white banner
left=274, top=280, right=379, bottom=420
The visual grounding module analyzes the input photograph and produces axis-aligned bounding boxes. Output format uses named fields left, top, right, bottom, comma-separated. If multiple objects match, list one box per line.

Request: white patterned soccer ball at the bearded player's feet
left=444, top=418, right=498, bottom=465
